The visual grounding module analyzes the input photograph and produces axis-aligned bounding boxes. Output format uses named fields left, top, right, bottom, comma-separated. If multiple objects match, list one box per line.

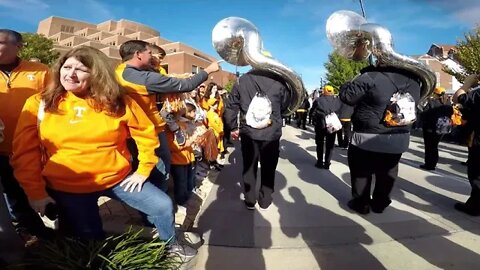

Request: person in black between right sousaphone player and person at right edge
left=420, top=87, right=453, bottom=171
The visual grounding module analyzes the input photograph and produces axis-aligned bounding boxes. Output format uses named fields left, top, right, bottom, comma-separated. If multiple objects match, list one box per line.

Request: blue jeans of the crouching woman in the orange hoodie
left=48, top=181, right=176, bottom=241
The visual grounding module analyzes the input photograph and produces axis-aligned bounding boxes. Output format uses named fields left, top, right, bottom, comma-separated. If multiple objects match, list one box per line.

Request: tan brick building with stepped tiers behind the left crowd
left=37, top=16, right=235, bottom=85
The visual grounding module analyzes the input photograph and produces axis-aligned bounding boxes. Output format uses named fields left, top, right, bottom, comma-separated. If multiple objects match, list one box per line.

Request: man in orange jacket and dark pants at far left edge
left=0, top=29, right=48, bottom=240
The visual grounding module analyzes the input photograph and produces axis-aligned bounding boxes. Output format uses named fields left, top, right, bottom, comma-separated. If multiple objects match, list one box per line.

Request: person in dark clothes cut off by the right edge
left=453, top=74, right=480, bottom=216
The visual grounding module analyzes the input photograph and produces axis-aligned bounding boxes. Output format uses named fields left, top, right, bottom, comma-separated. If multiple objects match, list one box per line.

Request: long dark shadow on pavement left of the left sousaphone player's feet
left=197, top=142, right=271, bottom=270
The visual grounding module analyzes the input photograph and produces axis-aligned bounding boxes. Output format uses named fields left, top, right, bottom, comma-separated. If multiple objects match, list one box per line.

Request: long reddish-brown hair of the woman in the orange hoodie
left=42, top=46, right=125, bottom=116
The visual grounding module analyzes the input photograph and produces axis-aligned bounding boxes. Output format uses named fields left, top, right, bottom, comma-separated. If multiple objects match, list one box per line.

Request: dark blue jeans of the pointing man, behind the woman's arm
left=127, top=132, right=171, bottom=192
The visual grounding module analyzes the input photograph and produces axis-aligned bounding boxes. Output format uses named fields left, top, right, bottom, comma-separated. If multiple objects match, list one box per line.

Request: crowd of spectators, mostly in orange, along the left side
left=0, top=29, right=232, bottom=259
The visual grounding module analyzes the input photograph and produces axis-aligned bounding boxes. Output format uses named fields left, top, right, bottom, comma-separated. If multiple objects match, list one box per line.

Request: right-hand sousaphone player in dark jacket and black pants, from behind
left=340, top=66, right=421, bottom=214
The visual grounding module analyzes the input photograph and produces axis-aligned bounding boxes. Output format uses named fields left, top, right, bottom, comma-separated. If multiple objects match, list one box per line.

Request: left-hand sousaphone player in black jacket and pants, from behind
left=224, top=69, right=289, bottom=210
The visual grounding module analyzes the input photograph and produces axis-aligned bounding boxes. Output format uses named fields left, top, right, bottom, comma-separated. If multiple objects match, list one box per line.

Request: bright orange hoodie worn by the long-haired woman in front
left=11, top=92, right=159, bottom=200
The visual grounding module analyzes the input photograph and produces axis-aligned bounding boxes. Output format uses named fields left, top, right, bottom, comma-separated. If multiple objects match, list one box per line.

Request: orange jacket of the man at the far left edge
left=0, top=60, right=49, bottom=156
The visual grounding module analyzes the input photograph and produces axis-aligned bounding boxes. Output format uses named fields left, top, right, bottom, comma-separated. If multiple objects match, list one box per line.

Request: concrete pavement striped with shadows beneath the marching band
left=189, top=126, right=480, bottom=270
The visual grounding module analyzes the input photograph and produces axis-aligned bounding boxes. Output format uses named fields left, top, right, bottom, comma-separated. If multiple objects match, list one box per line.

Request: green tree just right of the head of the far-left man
left=20, top=33, right=60, bottom=66
